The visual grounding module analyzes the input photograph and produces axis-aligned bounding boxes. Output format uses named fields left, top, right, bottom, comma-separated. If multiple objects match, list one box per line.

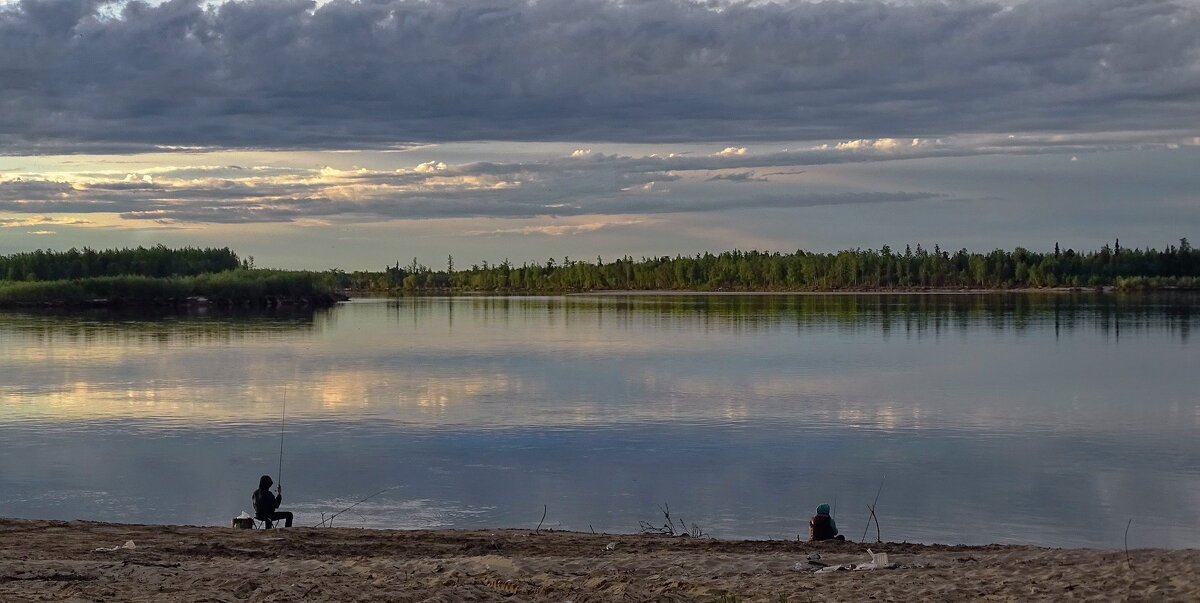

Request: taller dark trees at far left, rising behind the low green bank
left=0, top=245, right=241, bottom=281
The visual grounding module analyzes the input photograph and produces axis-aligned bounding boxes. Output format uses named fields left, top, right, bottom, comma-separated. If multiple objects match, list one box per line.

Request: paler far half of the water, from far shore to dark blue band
left=0, top=295, right=1200, bottom=432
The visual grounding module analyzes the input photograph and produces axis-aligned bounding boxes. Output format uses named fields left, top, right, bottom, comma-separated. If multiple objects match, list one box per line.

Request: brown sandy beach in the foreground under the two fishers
left=0, top=519, right=1200, bottom=603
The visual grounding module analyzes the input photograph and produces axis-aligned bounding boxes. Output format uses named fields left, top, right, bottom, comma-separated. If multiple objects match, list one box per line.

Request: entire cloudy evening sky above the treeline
left=0, top=0, right=1200, bottom=270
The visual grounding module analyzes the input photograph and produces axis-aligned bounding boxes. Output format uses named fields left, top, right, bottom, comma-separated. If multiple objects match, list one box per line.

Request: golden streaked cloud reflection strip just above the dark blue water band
left=0, top=350, right=1200, bottom=434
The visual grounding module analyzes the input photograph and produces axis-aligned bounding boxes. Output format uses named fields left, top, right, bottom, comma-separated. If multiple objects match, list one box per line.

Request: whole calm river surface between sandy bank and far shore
left=0, top=295, right=1200, bottom=548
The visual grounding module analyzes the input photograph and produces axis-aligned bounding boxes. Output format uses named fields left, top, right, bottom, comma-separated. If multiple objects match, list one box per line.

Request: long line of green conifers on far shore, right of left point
left=340, top=238, right=1200, bottom=292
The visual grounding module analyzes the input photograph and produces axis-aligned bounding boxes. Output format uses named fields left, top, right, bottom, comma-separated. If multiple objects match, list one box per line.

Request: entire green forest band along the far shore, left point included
left=0, top=238, right=1200, bottom=305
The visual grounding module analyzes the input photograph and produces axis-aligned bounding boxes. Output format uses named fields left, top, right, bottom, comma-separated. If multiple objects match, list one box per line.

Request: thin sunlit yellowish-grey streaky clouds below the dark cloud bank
left=0, top=141, right=964, bottom=222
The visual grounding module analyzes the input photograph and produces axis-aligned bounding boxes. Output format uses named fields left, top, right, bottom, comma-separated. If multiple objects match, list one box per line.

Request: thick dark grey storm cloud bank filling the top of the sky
left=0, top=0, right=1200, bottom=154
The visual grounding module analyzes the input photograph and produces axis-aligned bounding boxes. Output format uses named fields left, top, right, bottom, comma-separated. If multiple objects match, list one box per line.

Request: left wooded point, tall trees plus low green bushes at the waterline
left=0, top=245, right=343, bottom=306
